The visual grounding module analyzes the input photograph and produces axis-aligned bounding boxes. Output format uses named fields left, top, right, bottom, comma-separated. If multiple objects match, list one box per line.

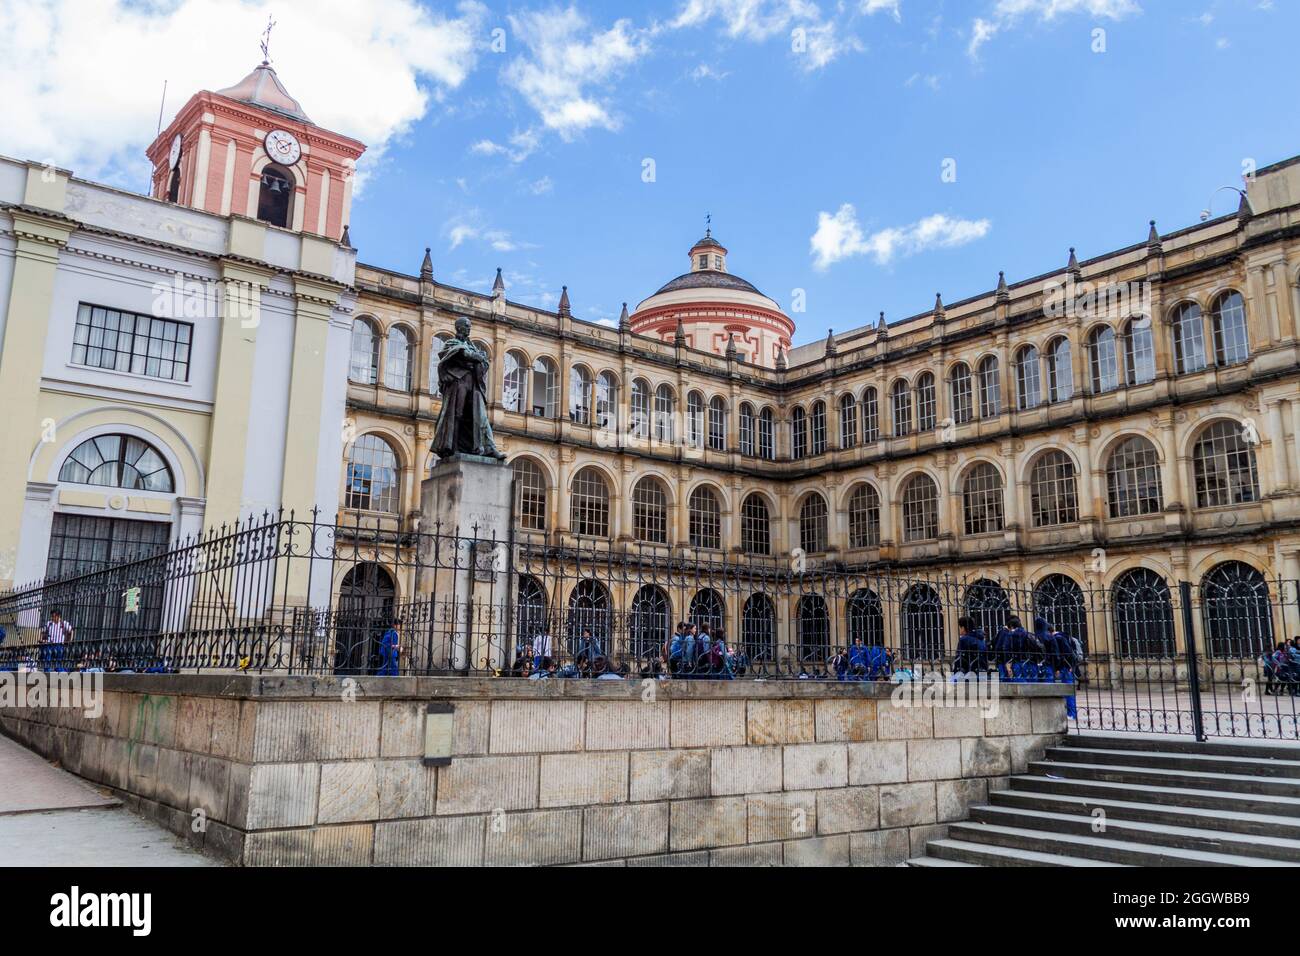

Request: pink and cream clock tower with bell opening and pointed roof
left=148, top=60, right=365, bottom=241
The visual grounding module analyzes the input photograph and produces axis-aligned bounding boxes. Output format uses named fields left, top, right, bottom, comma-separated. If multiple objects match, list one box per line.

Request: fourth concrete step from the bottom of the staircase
left=970, top=805, right=1300, bottom=865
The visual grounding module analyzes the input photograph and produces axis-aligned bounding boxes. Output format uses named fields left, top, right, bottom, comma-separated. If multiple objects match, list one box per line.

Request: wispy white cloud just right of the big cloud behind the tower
left=502, top=7, right=650, bottom=139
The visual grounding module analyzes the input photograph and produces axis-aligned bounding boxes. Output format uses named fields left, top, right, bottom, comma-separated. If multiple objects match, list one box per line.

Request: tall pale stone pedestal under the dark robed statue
left=412, top=455, right=514, bottom=671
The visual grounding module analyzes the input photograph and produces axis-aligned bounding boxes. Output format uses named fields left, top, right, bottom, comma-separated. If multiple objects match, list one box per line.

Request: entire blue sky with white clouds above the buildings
left=0, top=0, right=1300, bottom=345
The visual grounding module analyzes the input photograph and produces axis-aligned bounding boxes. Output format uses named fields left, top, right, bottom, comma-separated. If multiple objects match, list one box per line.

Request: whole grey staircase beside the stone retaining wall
left=907, top=734, right=1300, bottom=866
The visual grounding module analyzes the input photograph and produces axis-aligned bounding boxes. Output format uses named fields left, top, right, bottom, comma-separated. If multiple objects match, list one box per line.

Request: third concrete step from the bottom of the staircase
left=948, top=822, right=1300, bottom=866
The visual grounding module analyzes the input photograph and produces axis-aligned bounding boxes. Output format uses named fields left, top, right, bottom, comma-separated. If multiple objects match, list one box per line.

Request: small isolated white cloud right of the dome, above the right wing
left=809, top=203, right=992, bottom=272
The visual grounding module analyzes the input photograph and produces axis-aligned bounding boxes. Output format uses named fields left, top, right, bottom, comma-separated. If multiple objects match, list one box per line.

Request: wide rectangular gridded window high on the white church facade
left=73, top=303, right=194, bottom=381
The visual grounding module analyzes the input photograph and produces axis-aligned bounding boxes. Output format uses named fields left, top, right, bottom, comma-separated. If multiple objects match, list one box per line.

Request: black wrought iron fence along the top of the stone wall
left=0, top=515, right=1300, bottom=737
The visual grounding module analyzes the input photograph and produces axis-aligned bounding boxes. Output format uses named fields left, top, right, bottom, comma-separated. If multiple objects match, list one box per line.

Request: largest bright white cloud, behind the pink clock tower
left=0, top=0, right=486, bottom=187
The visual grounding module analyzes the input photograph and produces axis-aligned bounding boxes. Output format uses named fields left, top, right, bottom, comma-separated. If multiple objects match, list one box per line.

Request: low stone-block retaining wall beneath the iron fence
left=0, top=675, right=1065, bottom=866
